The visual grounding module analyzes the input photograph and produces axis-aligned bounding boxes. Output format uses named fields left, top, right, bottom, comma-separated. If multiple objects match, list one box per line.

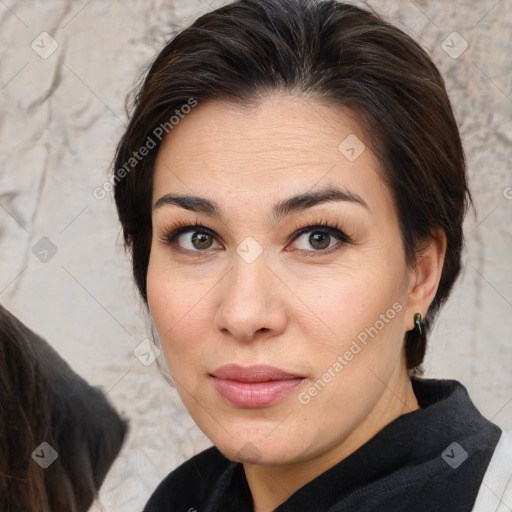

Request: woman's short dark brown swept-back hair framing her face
left=112, top=0, right=472, bottom=369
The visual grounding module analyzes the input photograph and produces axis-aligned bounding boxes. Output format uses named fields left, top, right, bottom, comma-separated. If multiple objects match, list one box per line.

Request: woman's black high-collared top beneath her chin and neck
left=143, top=377, right=502, bottom=512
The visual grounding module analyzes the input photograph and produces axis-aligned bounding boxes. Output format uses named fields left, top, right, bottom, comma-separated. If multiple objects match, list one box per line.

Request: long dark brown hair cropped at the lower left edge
left=0, top=306, right=128, bottom=512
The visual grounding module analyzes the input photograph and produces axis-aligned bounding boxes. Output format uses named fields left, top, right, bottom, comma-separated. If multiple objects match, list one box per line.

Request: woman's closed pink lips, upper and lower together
left=211, top=364, right=305, bottom=408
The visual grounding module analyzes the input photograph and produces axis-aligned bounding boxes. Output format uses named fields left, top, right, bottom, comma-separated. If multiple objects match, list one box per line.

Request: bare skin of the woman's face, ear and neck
left=147, top=93, right=446, bottom=512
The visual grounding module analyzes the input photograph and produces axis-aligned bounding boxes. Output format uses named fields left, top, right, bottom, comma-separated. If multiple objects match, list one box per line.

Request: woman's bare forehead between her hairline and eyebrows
left=153, top=94, right=392, bottom=220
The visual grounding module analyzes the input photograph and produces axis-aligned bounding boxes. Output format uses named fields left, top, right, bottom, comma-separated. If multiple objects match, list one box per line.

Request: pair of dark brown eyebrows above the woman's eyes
left=153, top=187, right=370, bottom=222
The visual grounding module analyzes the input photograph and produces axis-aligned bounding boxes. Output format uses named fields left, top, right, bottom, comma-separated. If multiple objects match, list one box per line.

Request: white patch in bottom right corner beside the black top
left=473, top=430, right=512, bottom=512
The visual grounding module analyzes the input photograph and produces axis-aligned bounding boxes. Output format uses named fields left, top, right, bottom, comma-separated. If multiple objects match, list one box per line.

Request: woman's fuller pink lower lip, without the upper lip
left=212, top=377, right=304, bottom=409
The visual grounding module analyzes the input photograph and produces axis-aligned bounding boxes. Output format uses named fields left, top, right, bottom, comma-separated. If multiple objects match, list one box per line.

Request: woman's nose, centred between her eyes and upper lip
left=216, top=253, right=288, bottom=341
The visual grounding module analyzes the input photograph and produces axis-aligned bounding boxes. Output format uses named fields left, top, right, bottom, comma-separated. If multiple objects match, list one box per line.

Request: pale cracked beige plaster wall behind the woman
left=0, top=0, right=512, bottom=512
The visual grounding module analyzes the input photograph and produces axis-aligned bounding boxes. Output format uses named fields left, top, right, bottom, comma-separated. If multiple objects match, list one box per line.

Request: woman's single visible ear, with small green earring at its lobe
left=404, top=228, right=446, bottom=331
